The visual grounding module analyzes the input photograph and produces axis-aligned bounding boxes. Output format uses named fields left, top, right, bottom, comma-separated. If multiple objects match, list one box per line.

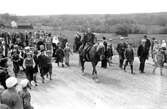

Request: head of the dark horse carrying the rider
left=96, top=43, right=105, bottom=60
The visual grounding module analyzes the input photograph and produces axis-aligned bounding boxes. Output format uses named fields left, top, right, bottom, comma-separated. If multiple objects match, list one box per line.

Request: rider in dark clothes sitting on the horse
left=81, top=28, right=97, bottom=59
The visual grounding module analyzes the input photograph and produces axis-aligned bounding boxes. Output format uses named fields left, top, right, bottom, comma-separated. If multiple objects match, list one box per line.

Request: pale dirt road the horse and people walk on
left=26, top=54, right=167, bottom=109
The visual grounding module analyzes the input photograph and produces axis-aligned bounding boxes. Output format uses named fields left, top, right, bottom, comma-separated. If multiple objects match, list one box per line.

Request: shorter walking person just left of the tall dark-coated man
left=124, top=43, right=134, bottom=74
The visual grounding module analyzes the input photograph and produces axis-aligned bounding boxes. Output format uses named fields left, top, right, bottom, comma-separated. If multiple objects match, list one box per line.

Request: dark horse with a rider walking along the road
left=79, top=43, right=104, bottom=81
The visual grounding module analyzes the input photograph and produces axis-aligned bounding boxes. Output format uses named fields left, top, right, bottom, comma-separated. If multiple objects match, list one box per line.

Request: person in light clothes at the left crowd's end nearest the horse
left=64, top=43, right=72, bottom=66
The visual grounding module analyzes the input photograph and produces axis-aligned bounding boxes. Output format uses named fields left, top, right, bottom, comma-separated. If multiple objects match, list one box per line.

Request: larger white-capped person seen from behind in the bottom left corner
left=1, top=77, right=23, bottom=109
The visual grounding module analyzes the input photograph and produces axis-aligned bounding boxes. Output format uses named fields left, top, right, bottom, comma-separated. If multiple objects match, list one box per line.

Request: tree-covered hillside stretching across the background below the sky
left=0, top=12, right=167, bottom=34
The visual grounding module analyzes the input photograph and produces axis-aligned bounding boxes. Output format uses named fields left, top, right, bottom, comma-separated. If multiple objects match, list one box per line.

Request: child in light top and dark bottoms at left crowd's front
left=23, top=52, right=35, bottom=82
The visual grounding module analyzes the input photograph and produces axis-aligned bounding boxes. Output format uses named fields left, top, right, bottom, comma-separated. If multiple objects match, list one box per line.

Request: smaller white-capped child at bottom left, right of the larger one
left=18, top=79, right=34, bottom=109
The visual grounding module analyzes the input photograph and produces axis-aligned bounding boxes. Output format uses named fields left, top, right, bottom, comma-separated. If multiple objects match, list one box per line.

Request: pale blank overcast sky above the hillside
left=0, top=0, right=167, bottom=15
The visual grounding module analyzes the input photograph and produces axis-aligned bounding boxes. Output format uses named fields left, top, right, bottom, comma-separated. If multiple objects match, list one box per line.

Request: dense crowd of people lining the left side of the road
left=0, top=31, right=72, bottom=109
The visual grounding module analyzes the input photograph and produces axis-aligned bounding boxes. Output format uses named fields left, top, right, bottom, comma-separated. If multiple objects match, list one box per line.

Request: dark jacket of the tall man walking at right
left=137, top=45, right=148, bottom=59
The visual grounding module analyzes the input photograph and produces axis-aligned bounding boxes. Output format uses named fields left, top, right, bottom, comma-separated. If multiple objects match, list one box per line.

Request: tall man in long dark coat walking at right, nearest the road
left=137, top=39, right=148, bottom=73
